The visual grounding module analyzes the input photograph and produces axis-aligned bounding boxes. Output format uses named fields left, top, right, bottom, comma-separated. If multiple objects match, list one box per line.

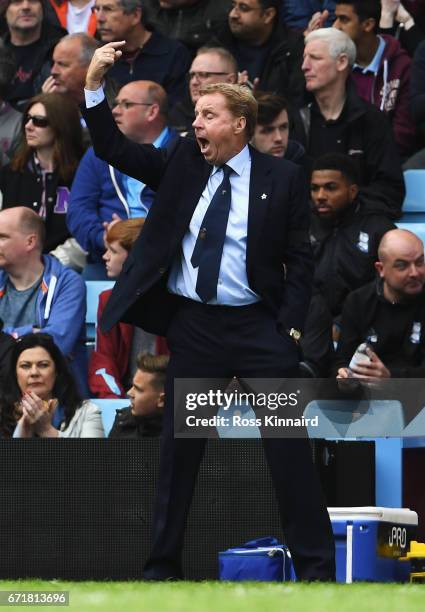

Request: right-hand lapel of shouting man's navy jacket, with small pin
left=246, top=146, right=272, bottom=269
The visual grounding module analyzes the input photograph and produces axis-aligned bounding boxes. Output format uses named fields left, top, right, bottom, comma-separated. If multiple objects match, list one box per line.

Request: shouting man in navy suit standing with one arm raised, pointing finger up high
left=85, top=43, right=335, bottom=580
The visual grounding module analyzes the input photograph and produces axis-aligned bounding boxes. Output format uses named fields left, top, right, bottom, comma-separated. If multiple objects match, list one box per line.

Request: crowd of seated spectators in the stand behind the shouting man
left=0, top=0, right=425, bottom=437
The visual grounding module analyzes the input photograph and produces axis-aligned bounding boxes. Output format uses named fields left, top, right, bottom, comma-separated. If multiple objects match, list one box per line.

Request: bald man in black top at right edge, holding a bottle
left=335, top=229, right=425, bottom=381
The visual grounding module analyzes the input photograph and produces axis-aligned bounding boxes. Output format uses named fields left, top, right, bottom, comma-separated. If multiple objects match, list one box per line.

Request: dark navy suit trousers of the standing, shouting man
left=144, top=298, right=335, bottom=580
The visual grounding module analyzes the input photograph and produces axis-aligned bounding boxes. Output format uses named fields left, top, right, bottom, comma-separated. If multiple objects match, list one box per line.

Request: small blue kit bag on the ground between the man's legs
left=218, top=537, right=296, bottom=582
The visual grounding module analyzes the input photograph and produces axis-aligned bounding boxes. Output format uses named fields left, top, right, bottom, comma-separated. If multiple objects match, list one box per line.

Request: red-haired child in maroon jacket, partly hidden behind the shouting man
left=89, top=219, right=161, bottom=398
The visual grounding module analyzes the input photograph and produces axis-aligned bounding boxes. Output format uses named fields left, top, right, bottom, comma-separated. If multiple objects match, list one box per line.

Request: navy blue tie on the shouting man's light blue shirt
left=190, top=164, right=233, bottom=302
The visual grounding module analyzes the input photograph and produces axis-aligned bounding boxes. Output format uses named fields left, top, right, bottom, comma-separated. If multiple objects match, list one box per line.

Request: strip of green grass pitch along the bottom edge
left=0, top=580, right=425, bottom=612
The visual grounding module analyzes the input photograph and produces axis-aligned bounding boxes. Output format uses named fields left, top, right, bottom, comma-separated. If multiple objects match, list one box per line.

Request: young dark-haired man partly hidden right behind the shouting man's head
left=251, top=91, right=305, bottom=164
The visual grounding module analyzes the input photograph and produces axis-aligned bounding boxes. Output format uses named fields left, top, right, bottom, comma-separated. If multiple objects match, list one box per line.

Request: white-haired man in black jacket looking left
left=297, top=28, right=405, bottom=218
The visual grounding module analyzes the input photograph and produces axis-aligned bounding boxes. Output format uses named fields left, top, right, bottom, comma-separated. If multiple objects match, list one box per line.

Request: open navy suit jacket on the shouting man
left=83, top=101, right=313, bottom=335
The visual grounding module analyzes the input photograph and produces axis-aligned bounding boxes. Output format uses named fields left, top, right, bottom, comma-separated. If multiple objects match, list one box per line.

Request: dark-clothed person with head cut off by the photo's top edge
left=143, top=0, right=230, bottom=54
